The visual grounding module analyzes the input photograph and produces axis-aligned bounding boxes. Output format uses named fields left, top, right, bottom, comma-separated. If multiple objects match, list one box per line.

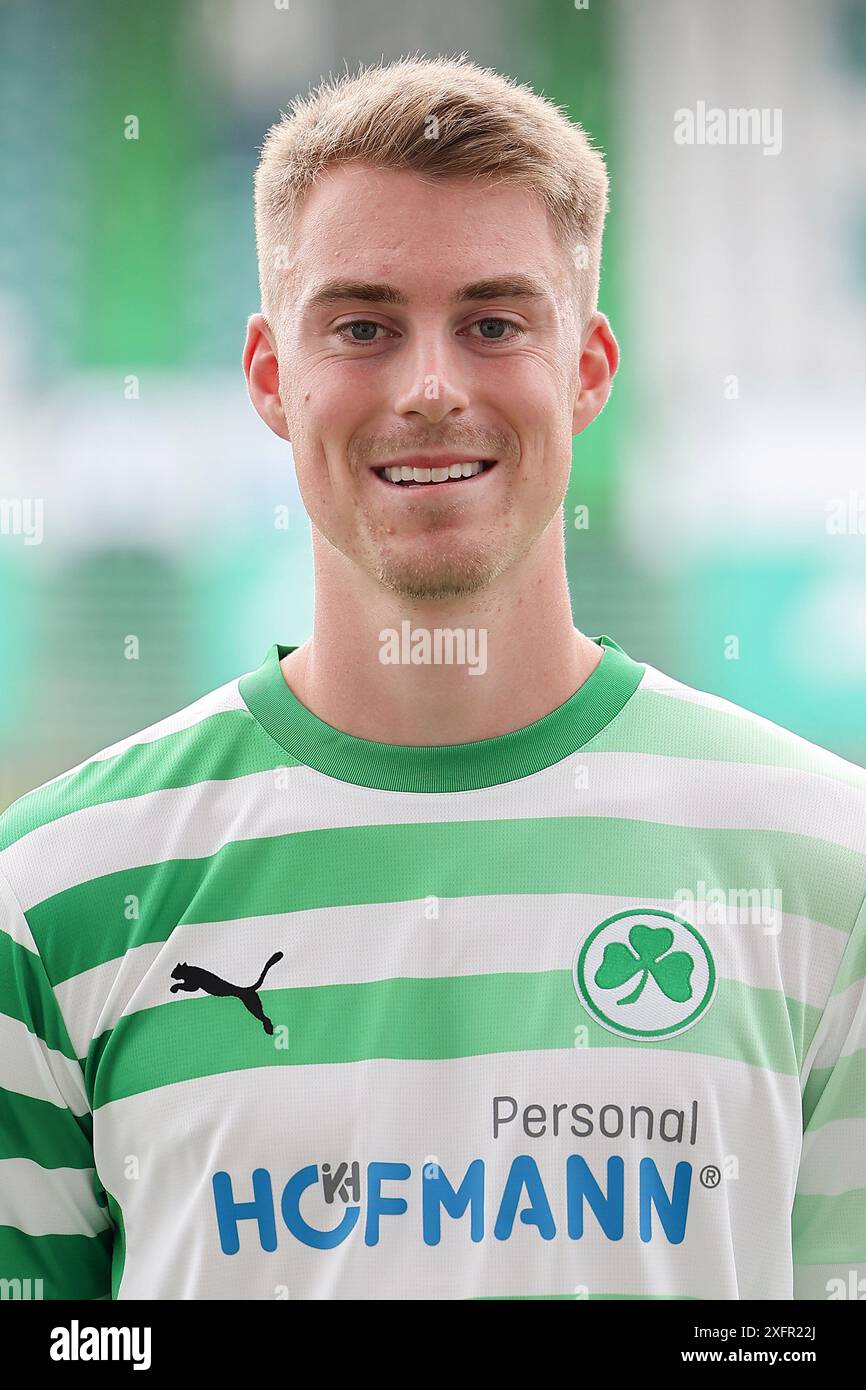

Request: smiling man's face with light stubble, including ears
left=245, top=164, right=616, bottom=599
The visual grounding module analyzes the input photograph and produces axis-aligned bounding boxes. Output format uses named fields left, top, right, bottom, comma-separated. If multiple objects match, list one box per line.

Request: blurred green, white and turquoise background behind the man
left=0, top=0, right=866, bottom=809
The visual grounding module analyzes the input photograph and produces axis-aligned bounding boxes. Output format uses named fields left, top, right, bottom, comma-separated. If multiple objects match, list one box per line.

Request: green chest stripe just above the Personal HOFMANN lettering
left=85, top=970, right=817, bottom=1111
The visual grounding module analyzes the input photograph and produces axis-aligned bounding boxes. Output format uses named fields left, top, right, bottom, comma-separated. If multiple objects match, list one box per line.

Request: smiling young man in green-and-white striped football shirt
left=0, top=51, right=866, bottom=1300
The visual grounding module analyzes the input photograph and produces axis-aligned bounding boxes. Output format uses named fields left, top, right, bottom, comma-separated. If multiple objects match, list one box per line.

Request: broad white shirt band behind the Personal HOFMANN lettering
left=95, top=1048, right=799, bottom=1300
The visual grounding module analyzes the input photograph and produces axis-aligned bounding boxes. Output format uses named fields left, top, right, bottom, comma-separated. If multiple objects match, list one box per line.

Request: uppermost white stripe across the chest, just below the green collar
left=6, top=749, right=866, bottom=909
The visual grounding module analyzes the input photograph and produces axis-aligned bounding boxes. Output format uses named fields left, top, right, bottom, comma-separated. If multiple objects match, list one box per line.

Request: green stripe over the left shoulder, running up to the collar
left=0, top=709, right=295, bottom=849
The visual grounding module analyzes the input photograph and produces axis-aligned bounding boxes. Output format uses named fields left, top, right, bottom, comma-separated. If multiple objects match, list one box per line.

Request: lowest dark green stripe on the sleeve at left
left=0, top=1226, right=113, bottom=1298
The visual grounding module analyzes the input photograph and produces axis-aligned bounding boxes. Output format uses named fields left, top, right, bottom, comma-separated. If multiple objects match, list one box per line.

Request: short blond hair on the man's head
left=254, top=54, right=607, bottom=333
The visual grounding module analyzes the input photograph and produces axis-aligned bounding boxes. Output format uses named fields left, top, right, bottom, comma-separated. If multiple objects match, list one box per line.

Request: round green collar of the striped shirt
left=239, top=637, right=645, bottom=792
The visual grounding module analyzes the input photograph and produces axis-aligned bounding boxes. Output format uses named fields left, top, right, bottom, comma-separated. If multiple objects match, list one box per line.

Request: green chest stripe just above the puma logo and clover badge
left=26, top=816, right=866, bottom=984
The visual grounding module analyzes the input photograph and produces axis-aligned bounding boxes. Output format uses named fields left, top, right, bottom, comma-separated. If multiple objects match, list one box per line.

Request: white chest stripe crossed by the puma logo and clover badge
left=56, top=892, right=845, bottom=1056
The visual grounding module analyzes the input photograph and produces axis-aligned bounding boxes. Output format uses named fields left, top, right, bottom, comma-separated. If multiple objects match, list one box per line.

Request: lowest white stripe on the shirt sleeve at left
left=0, top=1158, right=111, bottom=1236
